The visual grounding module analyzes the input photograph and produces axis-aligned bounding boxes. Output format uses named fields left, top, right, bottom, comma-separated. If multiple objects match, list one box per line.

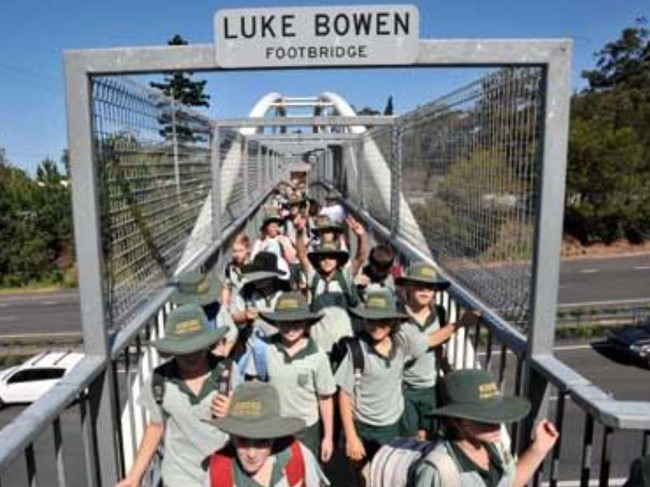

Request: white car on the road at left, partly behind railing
left=0, top=351, right=84, bottom=407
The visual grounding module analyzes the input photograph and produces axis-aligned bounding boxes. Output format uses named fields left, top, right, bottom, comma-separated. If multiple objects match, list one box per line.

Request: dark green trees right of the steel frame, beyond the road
left=565, top=20, right=650, bottom=244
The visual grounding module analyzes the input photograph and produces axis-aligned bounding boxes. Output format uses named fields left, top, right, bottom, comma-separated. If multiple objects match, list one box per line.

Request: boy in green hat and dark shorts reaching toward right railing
left=395, top=262, right=460, bottom=441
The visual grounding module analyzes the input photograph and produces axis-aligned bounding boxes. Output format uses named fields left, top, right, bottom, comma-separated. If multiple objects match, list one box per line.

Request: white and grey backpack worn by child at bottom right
left=367, top=438, right=462, bottom=487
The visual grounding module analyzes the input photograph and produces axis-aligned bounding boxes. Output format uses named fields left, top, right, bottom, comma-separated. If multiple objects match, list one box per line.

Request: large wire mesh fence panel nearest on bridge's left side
left=92, top=77, right=211, bottom=326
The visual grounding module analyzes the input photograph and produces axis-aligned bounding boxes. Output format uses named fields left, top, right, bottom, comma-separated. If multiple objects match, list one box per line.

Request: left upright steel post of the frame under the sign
left=65, top=54, right=119, bottom=487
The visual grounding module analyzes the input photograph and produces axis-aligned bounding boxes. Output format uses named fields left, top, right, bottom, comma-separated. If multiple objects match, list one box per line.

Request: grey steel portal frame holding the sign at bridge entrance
left=64, top=39, right=572, bottom=486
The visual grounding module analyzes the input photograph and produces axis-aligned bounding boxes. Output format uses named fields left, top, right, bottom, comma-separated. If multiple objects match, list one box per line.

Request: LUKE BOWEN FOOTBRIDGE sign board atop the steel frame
left=214, top=5, right=419, bottom=68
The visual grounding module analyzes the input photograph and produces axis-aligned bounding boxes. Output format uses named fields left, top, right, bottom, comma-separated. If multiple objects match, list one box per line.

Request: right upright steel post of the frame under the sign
left=518, top=44, right=571, bottom=451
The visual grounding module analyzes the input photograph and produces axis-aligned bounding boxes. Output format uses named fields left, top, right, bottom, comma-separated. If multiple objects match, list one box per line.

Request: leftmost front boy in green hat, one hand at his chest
left=117, top=304, right=237, bottom=487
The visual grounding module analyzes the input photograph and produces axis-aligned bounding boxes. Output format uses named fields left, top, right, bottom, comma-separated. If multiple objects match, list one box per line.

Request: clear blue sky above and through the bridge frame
left=0, top=0, right=650, bottom=174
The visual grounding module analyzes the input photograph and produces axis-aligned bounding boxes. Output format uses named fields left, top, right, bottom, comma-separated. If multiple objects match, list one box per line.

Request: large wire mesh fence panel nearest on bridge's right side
left=398, top=68, right=543, bottom=322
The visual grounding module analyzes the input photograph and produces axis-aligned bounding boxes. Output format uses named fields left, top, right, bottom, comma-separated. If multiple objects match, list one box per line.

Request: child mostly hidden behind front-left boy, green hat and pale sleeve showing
left=170, top=272, right=237, bottom=357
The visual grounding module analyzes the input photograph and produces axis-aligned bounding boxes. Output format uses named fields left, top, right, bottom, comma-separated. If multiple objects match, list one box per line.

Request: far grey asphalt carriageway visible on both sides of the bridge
left=0, top=254, right=650, bottom=337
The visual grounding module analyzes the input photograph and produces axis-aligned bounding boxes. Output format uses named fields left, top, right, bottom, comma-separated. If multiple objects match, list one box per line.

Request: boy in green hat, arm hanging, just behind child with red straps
left=251, top=292, right=336, bottom=462
